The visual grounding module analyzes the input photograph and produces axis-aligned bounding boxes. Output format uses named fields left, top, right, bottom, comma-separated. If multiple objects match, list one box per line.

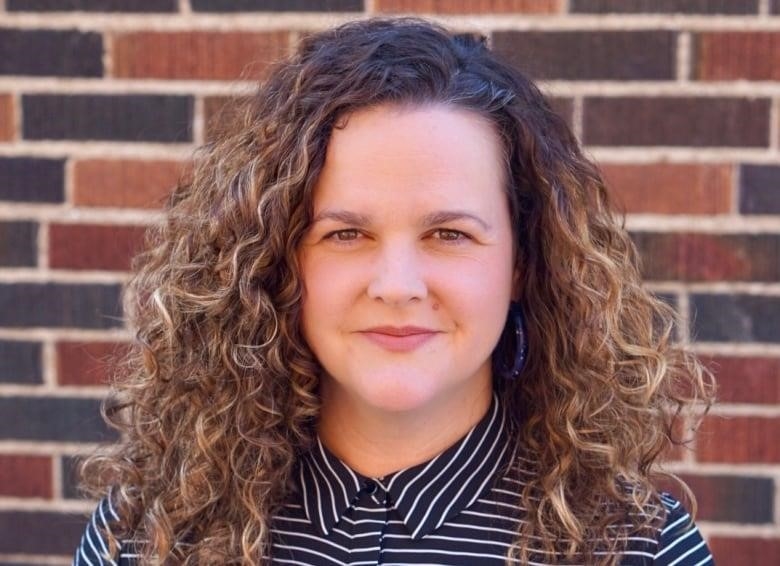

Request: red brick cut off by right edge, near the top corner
left=695, top=31, right=780, bottom=81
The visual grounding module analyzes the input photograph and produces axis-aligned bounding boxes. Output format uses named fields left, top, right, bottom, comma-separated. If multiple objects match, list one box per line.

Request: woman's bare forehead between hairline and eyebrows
left=314, top=105, right=505, bottom=214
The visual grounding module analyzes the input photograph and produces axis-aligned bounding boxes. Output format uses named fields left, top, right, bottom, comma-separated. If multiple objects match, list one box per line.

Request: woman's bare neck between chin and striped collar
left=317, top=383, right=492, bottom=478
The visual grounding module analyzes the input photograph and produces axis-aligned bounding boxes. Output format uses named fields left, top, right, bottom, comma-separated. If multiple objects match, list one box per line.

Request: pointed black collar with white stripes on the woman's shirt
left=299, top=393, right=509, bottom=540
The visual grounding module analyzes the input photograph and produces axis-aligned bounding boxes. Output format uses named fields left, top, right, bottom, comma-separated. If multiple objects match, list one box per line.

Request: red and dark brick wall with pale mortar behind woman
left=0, top=0, right=780, bottom=565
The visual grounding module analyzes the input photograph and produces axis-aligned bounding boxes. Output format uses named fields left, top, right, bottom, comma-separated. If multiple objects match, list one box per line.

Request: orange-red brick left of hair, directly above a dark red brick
left=73, top=159, right=183, bottom=208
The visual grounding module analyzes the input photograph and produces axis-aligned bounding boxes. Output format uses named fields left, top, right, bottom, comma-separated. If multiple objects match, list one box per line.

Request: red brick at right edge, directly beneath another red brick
left=696, top=415, right=780, bottom=464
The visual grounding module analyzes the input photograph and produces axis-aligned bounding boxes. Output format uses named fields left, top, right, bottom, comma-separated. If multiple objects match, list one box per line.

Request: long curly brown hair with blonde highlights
left=82, top=18, right=712, bottom=564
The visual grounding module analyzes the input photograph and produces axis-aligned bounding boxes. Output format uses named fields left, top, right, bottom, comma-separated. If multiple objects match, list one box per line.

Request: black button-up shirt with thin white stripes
left=73, top=395, right=714, bottom=566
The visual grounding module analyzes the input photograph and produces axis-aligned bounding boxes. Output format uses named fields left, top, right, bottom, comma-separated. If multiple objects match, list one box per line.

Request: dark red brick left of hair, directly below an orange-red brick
left=49, top=224, right=145, bottom=271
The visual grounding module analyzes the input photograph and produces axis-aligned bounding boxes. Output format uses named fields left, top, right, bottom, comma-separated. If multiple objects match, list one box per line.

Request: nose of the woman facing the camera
left=367, top=243, right=428, bottom=306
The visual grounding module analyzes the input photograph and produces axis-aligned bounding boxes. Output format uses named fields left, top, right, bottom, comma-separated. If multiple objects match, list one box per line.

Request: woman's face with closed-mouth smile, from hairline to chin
left=300, top=105, right=516, bottom=418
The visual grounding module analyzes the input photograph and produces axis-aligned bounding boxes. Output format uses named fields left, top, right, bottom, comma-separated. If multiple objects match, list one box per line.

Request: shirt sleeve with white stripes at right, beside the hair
left=653, top=493, right=715, bottom=566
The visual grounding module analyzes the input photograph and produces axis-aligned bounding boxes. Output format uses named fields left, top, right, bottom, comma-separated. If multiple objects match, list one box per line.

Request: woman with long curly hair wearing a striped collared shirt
left=75, top=15, right=712, bottom=565
